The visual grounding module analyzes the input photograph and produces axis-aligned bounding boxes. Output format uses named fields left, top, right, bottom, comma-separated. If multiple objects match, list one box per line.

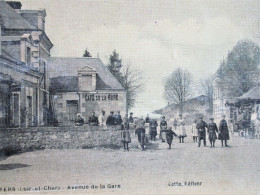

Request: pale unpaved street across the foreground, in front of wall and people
left=0, top=137, right=260, bottom=194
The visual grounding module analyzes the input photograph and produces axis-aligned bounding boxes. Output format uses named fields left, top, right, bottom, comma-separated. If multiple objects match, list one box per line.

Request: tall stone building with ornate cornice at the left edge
left=0, top=0, right=53, bottom=127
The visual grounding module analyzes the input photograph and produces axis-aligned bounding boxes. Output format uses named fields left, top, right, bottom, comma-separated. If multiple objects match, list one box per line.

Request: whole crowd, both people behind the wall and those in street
left=75, top=111, right=229, bottom=150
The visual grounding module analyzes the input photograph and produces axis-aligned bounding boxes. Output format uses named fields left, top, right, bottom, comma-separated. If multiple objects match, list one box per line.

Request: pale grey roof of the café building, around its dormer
left=48, top=57, right=124, bottom=90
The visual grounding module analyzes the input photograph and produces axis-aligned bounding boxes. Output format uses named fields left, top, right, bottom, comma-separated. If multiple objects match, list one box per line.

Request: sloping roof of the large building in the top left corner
left=0, top=0, right=36, bottom=30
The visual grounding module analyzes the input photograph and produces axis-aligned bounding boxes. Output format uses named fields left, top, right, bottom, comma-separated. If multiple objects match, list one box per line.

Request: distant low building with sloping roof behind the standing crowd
left=153, top=95, right=211, bottom=124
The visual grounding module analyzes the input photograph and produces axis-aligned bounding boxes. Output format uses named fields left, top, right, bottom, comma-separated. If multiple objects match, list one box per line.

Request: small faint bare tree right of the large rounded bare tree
left=199, top=77, right=213, bottom=113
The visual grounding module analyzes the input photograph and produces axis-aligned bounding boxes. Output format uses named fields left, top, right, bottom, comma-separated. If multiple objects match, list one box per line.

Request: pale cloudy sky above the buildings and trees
left=18, top=0, right=260, bottom=115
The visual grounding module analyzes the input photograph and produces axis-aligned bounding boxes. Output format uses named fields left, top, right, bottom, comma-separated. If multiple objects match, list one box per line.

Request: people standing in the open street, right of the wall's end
left=122, top=113, right=229, bottom=150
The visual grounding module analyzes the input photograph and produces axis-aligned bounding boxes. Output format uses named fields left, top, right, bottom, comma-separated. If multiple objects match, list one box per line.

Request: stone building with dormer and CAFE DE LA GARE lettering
left=49, top=57, right=126, bottom=125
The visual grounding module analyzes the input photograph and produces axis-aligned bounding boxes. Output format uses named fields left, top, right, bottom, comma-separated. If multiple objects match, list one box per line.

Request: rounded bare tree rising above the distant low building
left=164, top=68, right=192, bottom=110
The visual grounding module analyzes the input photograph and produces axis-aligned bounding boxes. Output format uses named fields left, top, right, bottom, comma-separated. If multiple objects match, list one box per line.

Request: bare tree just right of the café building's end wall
left=121, top=64, right=143, bottom=112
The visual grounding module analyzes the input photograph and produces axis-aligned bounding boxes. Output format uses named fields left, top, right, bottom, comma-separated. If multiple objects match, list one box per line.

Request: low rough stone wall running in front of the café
left=0, top=125, right=121, bottom=155
